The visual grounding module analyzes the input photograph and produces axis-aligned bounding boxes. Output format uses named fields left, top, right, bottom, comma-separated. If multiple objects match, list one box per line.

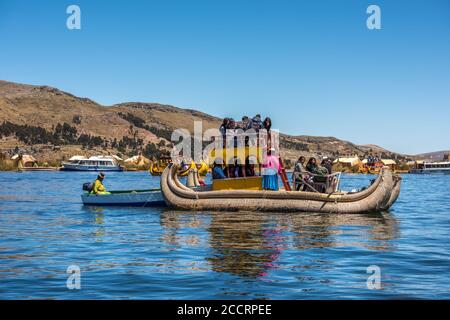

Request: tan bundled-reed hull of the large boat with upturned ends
left=161, top=164, right=401, bottom=213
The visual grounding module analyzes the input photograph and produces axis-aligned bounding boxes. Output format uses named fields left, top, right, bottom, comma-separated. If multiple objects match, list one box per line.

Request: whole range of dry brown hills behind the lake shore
left=0, top=80, right=405, bottom=161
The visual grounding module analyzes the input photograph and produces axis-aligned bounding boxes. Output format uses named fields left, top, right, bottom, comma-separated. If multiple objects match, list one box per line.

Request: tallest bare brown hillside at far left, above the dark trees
left=0, top=81, right=158, bottom=142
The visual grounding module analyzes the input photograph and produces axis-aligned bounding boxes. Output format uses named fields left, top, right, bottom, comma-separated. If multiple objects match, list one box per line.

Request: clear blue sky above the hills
left=0, top=0, right=450, bottom=154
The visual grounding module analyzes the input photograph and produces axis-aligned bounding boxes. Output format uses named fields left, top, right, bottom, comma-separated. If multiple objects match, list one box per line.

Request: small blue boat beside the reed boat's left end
left=81, top=189, right=166, bottom=207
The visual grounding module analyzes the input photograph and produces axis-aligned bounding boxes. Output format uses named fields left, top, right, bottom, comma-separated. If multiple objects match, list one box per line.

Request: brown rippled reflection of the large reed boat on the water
left=161, top=211, right=398, bottom=278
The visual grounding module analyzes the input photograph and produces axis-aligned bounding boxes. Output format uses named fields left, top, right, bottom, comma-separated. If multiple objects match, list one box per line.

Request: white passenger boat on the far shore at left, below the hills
left=61, top=156, right=123, bottom=171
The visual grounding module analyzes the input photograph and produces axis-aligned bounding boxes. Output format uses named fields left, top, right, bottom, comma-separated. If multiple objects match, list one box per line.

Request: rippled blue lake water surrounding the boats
left=0, top=172, right=450, bottom=299
